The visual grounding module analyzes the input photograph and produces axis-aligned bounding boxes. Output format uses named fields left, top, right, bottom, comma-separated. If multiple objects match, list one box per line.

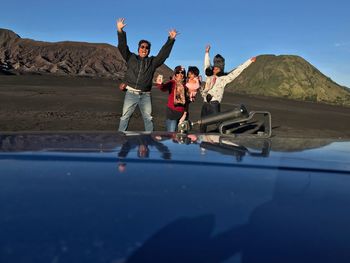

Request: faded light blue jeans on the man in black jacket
left=118, top=91, right=153, bottom=131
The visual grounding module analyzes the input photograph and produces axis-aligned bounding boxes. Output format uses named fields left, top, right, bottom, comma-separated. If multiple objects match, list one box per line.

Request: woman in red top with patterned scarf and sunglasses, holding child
left=157, top=66, right=189, bottom=132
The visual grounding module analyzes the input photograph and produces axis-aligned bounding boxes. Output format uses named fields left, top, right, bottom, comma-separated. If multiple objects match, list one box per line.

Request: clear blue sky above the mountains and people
left=0, top=0, right=350, bottom=87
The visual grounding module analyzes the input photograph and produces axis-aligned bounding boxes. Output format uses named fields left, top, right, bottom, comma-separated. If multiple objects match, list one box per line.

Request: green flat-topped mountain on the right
left=226, top=55, right=350, bottom=106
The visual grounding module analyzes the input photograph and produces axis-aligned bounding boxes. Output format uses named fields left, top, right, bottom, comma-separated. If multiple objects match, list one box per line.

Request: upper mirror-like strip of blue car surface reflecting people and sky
left=0, top=132, right=350, bottom=175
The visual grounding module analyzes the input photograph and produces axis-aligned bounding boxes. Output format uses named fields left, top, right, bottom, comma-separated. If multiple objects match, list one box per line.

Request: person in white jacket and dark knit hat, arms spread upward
left=200, top=45, right=256, bottom=132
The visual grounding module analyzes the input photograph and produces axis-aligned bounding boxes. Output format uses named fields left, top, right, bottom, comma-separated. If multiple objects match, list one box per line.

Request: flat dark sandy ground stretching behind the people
left=0, top=76, right=350, bottom=138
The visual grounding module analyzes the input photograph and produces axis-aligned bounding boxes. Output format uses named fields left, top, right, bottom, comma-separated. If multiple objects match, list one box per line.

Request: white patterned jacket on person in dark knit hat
left=201, top=52, right=253, bottom=103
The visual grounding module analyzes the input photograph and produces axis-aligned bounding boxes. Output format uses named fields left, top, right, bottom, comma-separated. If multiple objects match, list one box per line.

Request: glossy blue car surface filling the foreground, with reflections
left=0, top=132, right=350, bottom=263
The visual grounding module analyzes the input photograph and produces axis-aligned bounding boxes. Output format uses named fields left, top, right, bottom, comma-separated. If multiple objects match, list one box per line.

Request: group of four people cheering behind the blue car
left=117, top=18, right=256, bottom=132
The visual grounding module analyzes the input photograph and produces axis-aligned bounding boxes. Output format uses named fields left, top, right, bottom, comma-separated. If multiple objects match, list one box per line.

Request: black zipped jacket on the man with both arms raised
left=118, top=31, right=175, bottom=91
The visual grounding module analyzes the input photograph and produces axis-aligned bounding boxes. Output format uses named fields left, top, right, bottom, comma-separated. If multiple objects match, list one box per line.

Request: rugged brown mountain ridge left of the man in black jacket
left=0, top=29, right=172, bottom=79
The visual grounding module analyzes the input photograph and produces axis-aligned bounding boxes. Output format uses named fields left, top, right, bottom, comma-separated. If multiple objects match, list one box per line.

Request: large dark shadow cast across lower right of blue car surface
left=126, top=173, right=350, bottom=263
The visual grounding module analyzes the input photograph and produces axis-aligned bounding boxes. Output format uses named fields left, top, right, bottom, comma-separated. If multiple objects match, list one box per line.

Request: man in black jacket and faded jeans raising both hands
left=117, top=18, right=177, bottom=131
